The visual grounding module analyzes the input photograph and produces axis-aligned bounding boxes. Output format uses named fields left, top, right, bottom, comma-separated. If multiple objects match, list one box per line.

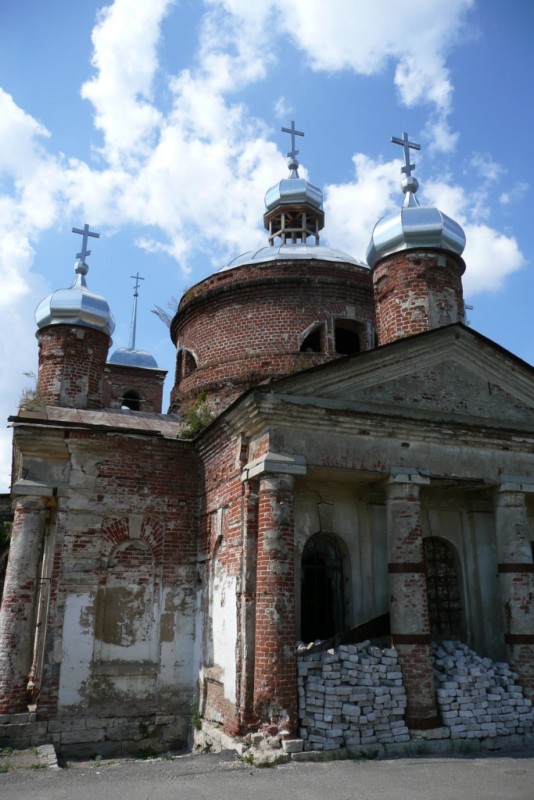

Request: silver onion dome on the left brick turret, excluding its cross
left=35, top=259, right=115, bottom=336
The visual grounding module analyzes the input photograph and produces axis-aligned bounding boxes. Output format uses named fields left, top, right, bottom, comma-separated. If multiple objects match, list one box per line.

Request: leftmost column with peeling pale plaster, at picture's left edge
left=0, top=497, right=46, bottom=714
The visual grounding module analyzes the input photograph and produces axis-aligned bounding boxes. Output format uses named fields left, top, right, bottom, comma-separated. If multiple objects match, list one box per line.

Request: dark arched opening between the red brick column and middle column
left=301, top=533, right=345, bottom=642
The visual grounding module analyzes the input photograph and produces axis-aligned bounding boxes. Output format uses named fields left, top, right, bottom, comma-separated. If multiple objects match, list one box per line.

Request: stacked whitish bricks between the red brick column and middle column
left=298, top=641, right=410, bottom=750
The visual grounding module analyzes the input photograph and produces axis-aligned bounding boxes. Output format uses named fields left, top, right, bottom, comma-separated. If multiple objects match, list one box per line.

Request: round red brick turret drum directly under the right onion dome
left=373, top=250, right=465, bottom=345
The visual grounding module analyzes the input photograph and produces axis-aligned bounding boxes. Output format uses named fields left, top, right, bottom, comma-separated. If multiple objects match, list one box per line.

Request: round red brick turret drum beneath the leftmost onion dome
left=37, top=325, right=110, bottom=408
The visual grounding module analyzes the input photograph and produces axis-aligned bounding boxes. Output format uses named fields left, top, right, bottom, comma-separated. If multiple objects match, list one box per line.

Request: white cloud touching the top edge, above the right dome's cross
left=210, top=0, right=474, bottom=152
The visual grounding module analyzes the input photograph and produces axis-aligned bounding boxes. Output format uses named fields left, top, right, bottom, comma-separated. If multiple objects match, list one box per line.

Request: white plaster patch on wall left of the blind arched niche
left=59, top=594, right=94, bottom=708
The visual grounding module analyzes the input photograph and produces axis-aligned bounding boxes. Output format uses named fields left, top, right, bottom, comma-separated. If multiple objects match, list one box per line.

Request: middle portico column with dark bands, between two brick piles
left=386, top=473, right=440, bottom=730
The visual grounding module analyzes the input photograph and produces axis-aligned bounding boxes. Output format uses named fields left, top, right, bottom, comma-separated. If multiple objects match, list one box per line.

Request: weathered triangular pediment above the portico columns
left=272, top=325, right=534, bottom=428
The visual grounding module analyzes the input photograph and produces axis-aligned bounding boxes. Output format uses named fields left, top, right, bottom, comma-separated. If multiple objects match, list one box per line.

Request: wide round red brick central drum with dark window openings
left=171, top=261, right=374, bottom=411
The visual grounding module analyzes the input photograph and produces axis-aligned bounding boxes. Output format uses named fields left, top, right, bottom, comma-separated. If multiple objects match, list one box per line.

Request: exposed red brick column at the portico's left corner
left=254, top=475, right=298, bottom=734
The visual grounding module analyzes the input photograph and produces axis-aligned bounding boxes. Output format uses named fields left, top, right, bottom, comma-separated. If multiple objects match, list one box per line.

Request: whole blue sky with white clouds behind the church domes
left=0, top=0, right=534, bottom=487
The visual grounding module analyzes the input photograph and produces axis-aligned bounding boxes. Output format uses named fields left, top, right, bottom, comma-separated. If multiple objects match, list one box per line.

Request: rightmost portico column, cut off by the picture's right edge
left=495, top=479, right=534, bottom=699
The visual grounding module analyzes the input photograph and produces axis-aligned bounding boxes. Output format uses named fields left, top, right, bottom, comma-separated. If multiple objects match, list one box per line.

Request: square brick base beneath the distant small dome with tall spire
left=103, top=364, right=167, bottom=414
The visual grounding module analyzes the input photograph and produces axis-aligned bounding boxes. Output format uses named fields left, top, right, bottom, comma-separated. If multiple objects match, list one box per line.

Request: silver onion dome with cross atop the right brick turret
left=367, top=133, right=465, bottom=267
